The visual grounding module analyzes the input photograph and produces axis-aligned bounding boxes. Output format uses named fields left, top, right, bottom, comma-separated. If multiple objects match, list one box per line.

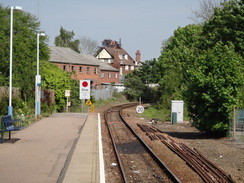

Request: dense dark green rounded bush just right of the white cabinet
left=186, top=42, right=244, bottom=133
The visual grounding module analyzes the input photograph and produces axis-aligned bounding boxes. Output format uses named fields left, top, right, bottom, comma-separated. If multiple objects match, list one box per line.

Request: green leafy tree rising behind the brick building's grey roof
left=54, top=26, right=80, bottom=53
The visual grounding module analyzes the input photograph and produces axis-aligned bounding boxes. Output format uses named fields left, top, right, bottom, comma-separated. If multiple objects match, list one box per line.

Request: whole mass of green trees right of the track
left=158, top=0, right=244, bottom=134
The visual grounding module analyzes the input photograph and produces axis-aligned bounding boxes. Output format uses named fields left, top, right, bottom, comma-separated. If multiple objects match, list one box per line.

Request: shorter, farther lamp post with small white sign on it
left=35, top=33, right=45, bottom=117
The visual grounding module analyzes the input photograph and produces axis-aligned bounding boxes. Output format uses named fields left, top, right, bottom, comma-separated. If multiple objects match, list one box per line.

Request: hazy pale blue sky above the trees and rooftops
left=0, top=0, right=200, bottom=61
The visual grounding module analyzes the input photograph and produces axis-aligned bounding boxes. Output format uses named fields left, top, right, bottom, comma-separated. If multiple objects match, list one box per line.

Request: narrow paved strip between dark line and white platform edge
left=63, top=114, right=100, bottom=183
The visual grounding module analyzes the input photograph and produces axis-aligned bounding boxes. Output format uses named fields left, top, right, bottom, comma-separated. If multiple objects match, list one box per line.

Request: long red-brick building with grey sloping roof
left=49, top=46, right=119, bottom=88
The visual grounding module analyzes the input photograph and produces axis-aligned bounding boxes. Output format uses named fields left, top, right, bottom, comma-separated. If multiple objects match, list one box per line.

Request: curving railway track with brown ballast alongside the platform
left=105, top=103, right=181, bottom=182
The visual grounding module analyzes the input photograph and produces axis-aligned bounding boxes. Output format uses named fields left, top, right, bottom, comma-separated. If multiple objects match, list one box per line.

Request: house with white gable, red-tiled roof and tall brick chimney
left=95, top=41, right=141, bottom=82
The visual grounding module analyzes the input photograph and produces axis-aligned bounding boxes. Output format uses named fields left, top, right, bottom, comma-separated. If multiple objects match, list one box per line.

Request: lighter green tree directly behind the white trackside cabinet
left=158, top=25, right=202, bottom=109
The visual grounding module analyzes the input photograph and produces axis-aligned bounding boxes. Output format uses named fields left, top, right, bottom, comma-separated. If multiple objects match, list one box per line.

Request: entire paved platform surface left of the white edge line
left=0, top=113, right=100, bottom=183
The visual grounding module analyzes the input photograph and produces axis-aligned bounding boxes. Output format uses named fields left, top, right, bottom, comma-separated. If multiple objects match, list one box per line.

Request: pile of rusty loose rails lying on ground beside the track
left=137, top=124, right=234, bottom=183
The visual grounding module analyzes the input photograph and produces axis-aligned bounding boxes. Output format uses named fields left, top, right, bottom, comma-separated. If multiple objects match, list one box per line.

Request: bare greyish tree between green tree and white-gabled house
left=79, top=36, right=98, bottom=55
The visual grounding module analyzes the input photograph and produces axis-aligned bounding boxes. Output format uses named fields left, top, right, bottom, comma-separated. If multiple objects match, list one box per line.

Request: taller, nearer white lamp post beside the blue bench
left=8, top=6, right=22, bottom=116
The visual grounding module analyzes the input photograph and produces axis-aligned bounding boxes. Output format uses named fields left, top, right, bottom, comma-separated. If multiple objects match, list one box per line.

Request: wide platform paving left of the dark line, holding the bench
left=0, top=113, right=87, bottom=183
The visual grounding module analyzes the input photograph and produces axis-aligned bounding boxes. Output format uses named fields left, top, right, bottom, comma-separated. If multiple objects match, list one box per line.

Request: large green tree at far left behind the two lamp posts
left=0, top=5, right=49, bottom=105
